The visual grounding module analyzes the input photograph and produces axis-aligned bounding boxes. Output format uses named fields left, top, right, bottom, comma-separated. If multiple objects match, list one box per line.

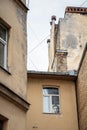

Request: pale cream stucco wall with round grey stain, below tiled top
left=57, top=13, right=87, bottom=70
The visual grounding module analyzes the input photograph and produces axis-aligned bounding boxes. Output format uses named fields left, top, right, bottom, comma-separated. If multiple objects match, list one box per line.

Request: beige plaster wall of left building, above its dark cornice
left=0, top=0, right=27, bottom=98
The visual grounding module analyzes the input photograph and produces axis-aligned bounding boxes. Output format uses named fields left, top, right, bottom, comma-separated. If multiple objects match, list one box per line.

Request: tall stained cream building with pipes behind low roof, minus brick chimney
left=49, top=7, right=87, bottom=72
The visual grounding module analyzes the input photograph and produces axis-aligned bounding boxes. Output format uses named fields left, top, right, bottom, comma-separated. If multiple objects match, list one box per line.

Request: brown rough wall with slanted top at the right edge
left=77, top=45, right=87, bottom=130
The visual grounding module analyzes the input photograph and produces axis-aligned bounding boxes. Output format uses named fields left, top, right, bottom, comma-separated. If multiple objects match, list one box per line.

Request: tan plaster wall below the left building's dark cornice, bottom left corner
left=0, top=96, right=26, bottom=130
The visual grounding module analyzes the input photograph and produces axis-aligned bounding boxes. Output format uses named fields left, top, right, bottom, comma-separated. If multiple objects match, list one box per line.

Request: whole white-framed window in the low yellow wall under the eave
left=43, top=87, right=60, bottom=113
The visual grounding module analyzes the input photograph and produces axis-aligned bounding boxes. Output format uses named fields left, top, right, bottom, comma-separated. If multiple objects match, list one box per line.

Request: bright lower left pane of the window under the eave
left=43, top=96, right=50, bottom=112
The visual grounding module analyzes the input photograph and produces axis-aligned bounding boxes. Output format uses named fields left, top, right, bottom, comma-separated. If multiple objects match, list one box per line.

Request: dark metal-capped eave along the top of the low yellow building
left=27, top=70, right=77, bottom=80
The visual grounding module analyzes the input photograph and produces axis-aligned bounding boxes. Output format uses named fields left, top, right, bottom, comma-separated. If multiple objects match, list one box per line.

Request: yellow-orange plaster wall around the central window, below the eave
left=27, top=78, right=78, bottom=130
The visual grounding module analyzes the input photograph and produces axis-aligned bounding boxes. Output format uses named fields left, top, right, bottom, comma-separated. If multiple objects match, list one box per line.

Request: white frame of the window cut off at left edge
left=0, top=23, right=8, bottom=69
